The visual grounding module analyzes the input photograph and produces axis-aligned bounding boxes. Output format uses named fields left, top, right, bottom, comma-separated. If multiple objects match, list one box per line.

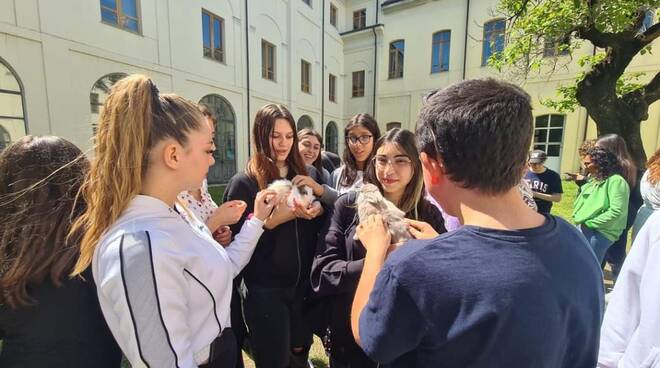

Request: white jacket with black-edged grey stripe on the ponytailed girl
left=92, top=195, right=263, bottom=368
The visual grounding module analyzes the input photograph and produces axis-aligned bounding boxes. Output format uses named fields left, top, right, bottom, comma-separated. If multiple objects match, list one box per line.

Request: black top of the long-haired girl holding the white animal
left=224, top=166, right=327, bottom=288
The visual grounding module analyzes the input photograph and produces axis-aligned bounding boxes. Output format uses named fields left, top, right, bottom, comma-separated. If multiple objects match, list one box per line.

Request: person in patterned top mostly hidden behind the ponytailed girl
left=178, top=105, right=246, bottom=246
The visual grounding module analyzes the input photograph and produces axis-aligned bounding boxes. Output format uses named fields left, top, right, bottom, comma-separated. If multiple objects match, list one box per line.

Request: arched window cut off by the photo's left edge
left=0, top=58, right=27, bottom=151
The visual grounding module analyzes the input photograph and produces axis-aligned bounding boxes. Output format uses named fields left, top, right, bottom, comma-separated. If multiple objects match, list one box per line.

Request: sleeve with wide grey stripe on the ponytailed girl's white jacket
left=115, top=232, right=197, bottom=368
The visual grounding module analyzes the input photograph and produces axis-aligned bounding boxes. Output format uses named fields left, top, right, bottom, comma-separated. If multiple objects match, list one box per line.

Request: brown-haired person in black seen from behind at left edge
left=0, top=135, right=121, bottom=368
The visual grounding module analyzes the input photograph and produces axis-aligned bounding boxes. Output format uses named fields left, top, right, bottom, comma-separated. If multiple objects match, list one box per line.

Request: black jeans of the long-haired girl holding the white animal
left=243, top=284, right=312, bottom=368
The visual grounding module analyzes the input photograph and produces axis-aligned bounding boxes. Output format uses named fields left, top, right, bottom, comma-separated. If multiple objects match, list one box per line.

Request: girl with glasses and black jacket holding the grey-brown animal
left=311, top=128, right=446, bottom=368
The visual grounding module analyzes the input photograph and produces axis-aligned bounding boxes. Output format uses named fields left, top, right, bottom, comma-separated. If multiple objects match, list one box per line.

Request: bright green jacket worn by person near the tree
left=573, top=175, right=630, bottom=241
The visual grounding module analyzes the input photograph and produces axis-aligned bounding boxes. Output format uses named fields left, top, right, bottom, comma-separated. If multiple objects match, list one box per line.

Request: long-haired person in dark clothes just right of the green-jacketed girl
left=596, top=134, right=644, bottom=280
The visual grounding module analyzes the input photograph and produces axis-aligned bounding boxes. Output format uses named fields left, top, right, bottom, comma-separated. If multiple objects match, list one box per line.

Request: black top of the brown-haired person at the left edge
left=0, top=267, right=121, bottom=368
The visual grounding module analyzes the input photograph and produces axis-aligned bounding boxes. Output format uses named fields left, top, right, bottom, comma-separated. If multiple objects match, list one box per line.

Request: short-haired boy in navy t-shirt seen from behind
left=351, top=79, right=603, bottom=368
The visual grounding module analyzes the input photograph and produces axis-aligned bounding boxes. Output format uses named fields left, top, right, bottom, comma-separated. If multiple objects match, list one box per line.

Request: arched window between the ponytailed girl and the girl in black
left=199, top=94, right=236, bottom=184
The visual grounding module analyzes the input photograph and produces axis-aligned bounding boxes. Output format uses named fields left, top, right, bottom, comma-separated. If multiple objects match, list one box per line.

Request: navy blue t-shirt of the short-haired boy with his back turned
left=360, top=215, right=603, bottom=368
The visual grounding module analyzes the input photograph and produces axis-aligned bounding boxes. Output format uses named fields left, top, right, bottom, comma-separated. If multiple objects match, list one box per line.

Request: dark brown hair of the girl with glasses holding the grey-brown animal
left=364, top=128, right=426, bottom=220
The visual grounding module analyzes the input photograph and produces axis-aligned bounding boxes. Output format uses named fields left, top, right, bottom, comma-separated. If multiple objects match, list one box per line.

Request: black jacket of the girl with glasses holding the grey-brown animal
left=311, top=192, right=447, bottom=362
